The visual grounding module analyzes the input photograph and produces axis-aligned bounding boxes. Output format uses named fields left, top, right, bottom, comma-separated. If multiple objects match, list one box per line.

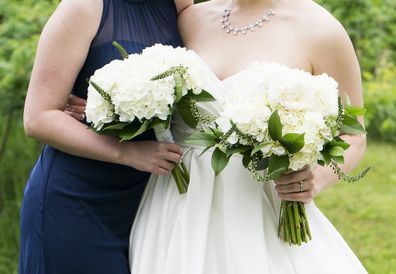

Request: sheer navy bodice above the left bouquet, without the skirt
left=73, top=0, right=181, bottom=98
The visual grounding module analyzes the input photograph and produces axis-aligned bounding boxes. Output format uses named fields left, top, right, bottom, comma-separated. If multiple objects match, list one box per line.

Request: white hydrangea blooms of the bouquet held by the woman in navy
left=86, top=44, right=209, bottom=130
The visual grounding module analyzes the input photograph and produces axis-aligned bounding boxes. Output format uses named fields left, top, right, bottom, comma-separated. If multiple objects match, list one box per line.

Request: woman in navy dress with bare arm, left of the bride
left=19, top=0, right=192, bottom=274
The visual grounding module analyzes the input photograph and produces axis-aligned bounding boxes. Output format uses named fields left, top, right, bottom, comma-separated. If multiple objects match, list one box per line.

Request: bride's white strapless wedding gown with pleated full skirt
left=130, top=62, right=367, bottom=274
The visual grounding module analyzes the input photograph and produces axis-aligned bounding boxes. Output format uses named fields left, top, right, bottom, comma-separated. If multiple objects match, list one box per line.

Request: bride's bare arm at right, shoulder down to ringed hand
left=276, top=18, right=366, bottom=202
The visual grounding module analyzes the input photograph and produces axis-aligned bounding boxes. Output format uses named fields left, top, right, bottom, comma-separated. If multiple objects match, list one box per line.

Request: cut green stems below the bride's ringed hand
left=278, top=200, right=312, bottom=245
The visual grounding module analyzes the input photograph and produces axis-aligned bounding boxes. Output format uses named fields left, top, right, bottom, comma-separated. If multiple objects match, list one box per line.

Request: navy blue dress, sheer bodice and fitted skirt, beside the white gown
left=19, top=0, right=181, bottom=274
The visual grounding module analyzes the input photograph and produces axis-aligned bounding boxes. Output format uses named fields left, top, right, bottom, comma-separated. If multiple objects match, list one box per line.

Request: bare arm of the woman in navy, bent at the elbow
left=24, top=0, right=181, bottom=174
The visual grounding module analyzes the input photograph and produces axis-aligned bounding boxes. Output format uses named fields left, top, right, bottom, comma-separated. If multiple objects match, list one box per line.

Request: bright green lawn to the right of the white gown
left=316, top=142, right=396, bottom=274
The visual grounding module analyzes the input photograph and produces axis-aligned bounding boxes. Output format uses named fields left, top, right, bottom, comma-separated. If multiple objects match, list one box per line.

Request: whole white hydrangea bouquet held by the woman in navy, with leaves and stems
left=85, top=42, right=214, bottom=193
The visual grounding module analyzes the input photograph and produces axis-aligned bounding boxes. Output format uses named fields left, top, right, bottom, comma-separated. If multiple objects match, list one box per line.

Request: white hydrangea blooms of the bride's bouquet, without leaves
left=217, top=63, right=339, bottom=170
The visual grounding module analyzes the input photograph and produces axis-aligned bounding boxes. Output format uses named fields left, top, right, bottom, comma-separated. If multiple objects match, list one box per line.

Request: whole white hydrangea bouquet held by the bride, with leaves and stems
left=189, top=63, right=368, bottom=245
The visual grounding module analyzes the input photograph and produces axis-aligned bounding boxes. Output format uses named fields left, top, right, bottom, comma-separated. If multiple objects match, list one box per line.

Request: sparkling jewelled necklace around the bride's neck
left=221, top=1, right=279, bottom=35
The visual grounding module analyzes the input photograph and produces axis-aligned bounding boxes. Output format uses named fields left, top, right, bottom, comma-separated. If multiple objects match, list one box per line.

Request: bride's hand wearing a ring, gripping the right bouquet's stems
left=274, top=167, right=321, bottom=203
